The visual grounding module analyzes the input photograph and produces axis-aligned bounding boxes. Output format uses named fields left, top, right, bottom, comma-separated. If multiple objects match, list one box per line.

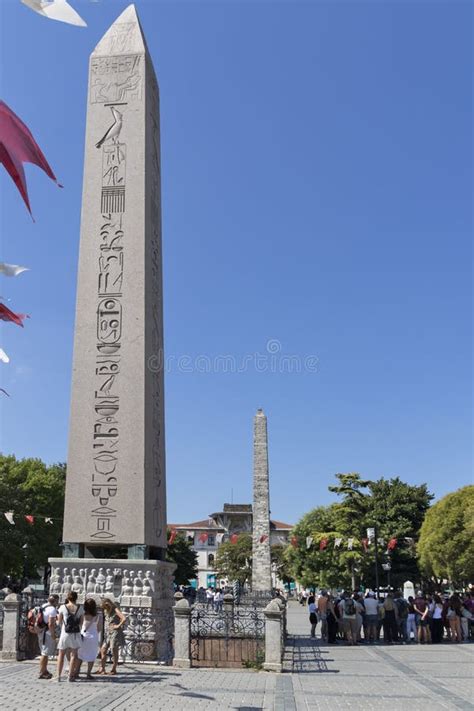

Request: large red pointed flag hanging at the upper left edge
left=0, top=101, right=62, bottom=215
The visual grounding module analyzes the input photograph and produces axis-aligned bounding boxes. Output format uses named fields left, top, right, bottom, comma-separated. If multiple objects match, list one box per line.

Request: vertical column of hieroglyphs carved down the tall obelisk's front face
left=91, top=107, right=126, bottom=544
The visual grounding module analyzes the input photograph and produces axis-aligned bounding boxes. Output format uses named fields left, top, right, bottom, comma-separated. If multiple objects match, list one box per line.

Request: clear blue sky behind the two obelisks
left=0, top=0, right=473, bottom=523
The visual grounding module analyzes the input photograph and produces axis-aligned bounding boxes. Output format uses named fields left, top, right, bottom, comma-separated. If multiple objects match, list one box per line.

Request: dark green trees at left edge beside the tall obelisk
left=0, top=455, right=66, bottom=581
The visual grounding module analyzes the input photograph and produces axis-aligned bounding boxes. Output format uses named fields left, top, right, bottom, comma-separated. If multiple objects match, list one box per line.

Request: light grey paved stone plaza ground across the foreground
left=0, top=603, right=474, bottom=711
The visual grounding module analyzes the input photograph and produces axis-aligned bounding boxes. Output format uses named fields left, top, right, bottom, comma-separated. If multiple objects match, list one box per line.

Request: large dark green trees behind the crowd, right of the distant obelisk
left=286, top=473, right=432, bottom=588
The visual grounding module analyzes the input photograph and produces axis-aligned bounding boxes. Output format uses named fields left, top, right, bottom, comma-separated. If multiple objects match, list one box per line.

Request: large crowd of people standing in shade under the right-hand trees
left=300, top=590, right=474, bottom=645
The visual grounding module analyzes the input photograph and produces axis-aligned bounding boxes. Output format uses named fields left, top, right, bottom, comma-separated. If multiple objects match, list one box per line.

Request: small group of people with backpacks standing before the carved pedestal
left=38, top=592, right=125, bottom=682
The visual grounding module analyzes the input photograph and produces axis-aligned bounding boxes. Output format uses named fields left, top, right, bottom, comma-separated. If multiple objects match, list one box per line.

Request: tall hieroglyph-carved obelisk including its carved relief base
left=51, top=5, right=173, bottom=660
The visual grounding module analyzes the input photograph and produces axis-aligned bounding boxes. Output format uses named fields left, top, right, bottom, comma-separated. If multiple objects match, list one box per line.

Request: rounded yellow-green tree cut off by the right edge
left=418, top=485, right=474, bottom=587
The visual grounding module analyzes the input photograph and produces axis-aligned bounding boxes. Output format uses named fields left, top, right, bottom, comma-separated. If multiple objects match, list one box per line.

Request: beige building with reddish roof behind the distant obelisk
left=168, top=504, right=293, bottom=588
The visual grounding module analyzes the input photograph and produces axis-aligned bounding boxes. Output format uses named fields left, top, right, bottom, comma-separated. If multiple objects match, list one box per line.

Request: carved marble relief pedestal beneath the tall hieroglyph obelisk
left=49, top=558, right=176, bottom=662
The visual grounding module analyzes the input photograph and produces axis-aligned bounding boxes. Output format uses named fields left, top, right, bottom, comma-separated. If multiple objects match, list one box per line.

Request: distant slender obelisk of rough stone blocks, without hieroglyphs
left=252, top=410, right=272, bottom=593
